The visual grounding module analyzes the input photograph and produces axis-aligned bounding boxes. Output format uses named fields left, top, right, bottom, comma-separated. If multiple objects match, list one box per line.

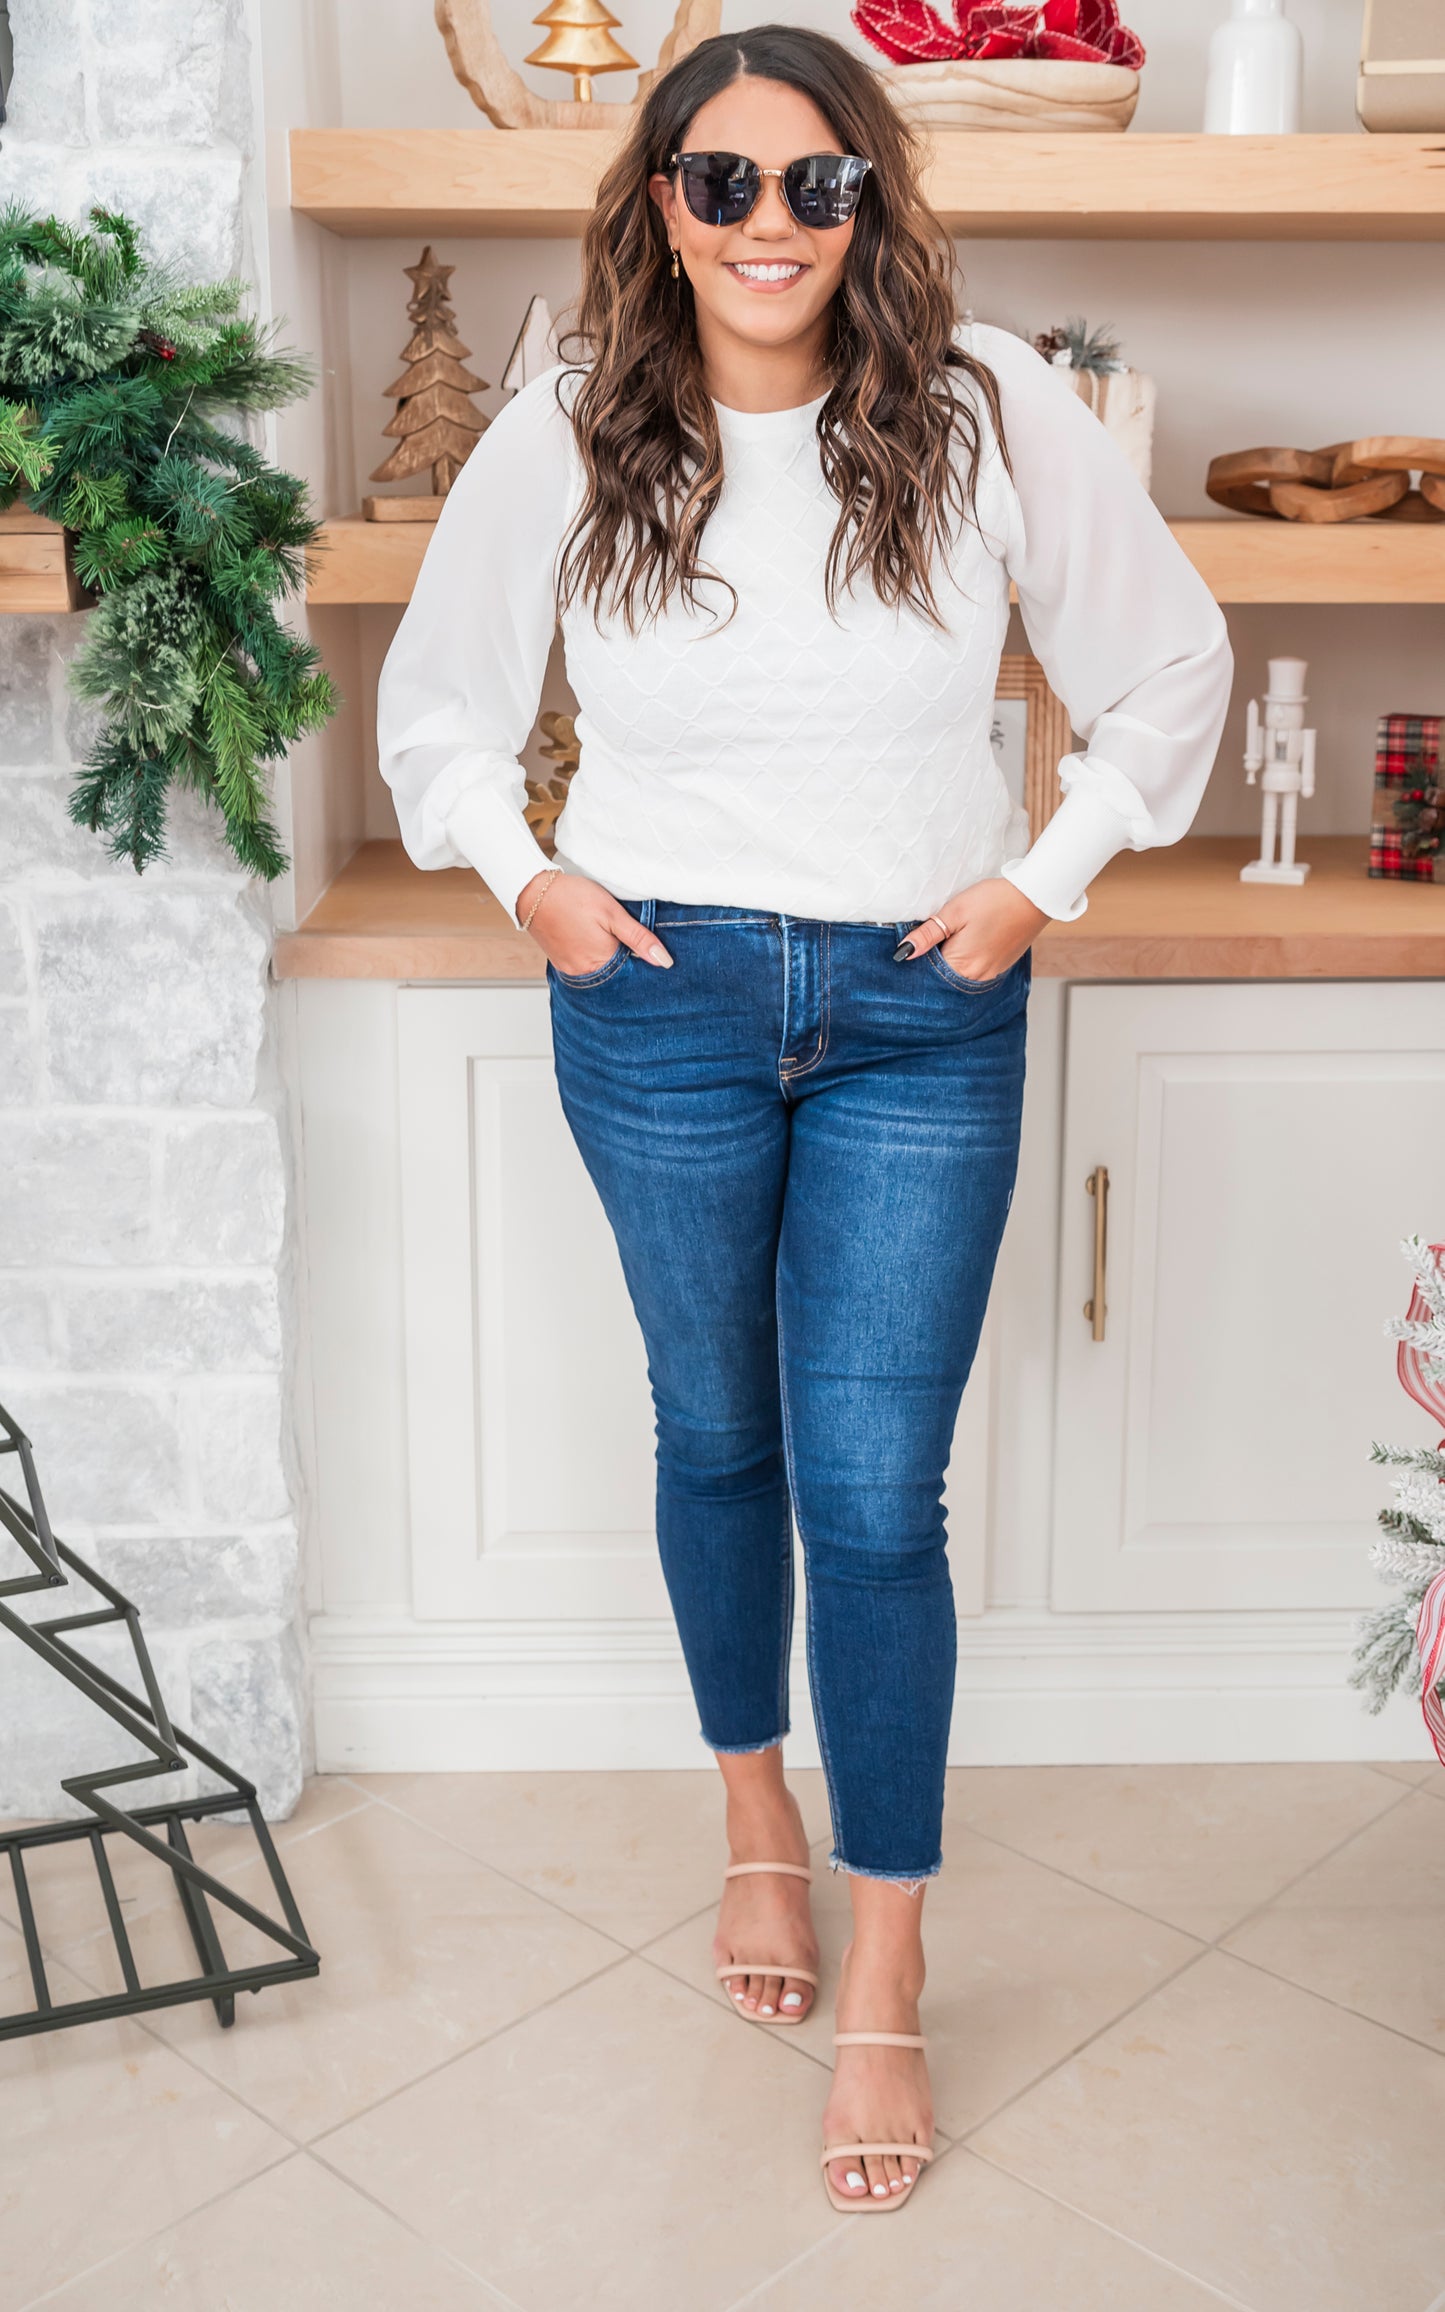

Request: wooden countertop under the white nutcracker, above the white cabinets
left=273, top=835, right=1445, bottom=980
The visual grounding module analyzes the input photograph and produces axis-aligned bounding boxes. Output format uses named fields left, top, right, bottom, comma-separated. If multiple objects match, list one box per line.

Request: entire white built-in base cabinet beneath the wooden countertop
left=294, top=980, right=1445, bottom=1769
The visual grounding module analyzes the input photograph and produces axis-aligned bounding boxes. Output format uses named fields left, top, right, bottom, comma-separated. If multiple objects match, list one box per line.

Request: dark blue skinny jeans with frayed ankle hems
left=548, top=899, right=1029, bottom=1884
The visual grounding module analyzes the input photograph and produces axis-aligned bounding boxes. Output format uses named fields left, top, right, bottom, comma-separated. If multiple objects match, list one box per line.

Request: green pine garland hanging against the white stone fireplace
left=0, top=208, right=338, bottom=879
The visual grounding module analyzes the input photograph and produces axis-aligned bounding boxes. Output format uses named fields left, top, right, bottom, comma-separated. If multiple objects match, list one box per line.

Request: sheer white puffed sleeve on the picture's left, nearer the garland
left=377, top=370, right=576, bottom=922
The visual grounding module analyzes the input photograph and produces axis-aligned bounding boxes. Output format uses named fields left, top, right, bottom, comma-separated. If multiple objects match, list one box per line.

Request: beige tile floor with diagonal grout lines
left=0, top=1764, right=1445, bottom=2312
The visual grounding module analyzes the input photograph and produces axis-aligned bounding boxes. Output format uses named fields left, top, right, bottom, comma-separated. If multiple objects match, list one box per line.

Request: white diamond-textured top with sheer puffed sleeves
left=377, top=326, right=1232, bottom=922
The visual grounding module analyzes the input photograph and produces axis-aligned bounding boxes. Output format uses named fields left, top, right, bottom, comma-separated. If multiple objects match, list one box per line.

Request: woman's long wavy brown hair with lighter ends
left=560, top=23, right=1008, bottom=631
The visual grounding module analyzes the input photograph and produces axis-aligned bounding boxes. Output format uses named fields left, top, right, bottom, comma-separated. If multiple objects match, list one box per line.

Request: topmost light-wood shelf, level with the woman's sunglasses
left=291, top=129, right=1445, bottom=240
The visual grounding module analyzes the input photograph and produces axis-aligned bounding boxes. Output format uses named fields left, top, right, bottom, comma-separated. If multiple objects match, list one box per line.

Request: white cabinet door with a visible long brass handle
left=1052, top=983, right=1445, bottom=1609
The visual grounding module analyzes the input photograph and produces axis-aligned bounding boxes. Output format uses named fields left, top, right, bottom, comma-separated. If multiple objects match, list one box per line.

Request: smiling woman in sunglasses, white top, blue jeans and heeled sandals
left=379, top=25, right=1230, bottom=2210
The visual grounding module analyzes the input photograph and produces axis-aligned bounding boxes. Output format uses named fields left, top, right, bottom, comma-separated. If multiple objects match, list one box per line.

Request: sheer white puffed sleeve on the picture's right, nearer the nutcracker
left=969, top=328, right=1235, bottom=922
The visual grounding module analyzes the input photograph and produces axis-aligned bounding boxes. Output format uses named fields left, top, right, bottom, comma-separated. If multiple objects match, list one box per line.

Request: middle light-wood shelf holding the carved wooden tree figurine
left=305, top=516, right=1445, bottom=603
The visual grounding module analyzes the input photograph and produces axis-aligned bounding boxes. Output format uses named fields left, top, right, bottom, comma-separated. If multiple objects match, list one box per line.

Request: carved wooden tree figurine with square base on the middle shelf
left=361, top=243, right=488, bottom=523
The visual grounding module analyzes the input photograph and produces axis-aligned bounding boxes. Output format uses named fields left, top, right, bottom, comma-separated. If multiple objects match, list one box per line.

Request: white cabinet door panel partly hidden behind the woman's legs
left=398, top=987, right=992, bottom=1623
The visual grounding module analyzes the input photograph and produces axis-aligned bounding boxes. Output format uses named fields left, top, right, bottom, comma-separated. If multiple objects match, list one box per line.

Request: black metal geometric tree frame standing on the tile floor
left=0, top=1406, right=321, bottom=2039
